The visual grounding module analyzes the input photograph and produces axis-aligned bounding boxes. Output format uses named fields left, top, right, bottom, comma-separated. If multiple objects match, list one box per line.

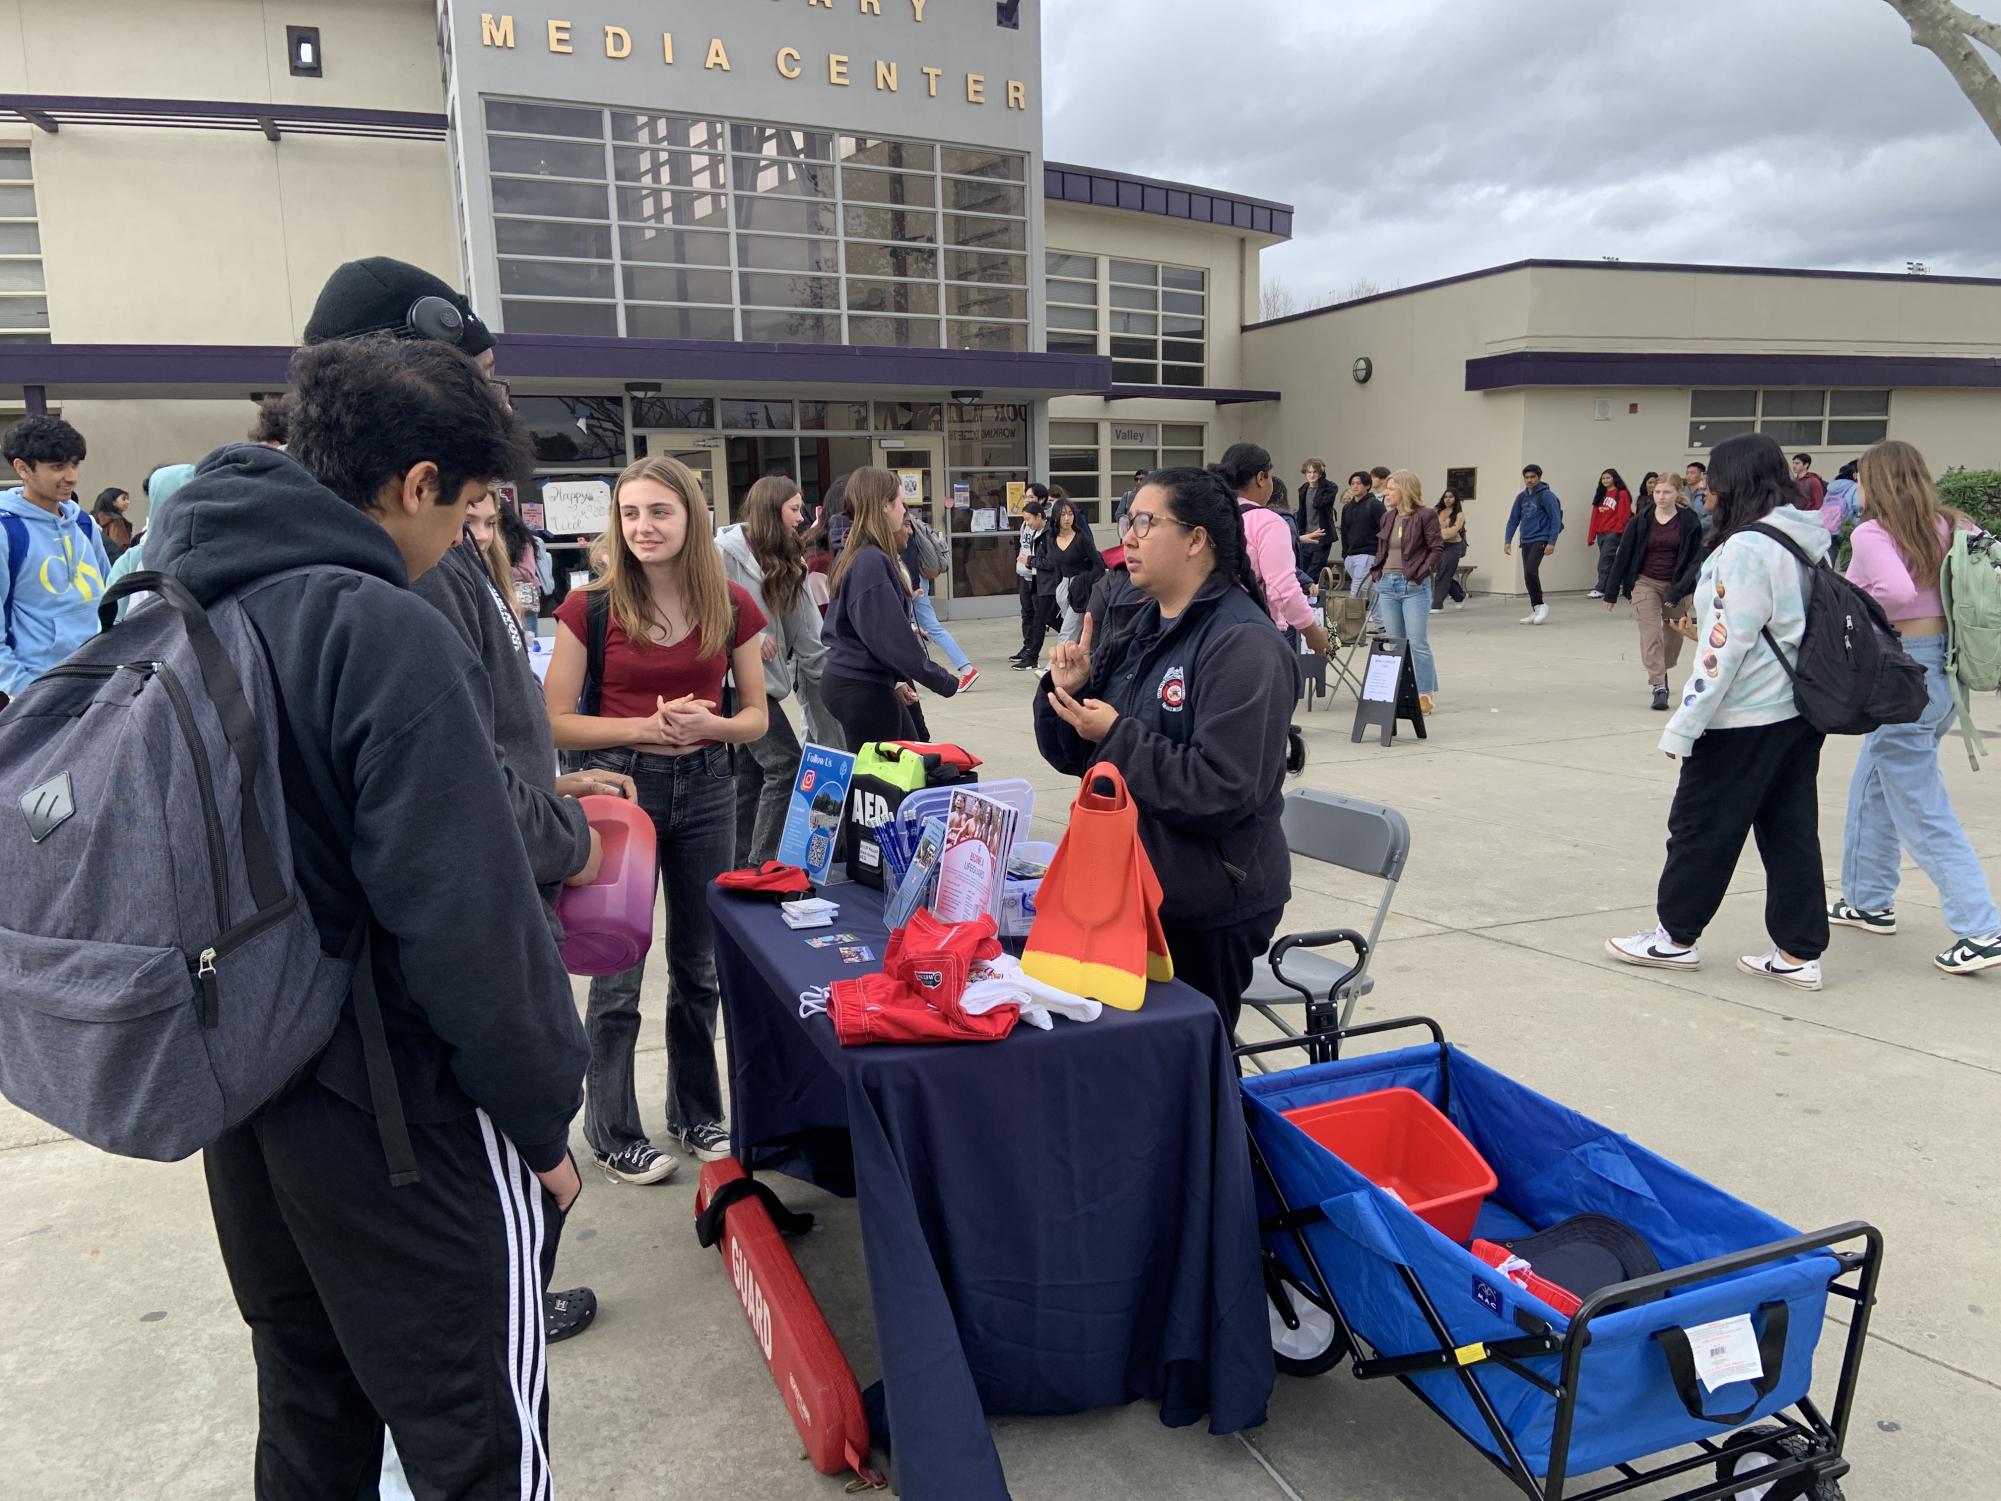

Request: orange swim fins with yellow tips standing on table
left=1021, top=763, right=1173, bottom=1011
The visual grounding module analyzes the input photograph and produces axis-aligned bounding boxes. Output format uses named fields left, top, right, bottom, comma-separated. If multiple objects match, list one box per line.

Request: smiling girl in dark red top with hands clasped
left=546, top=458, right=766, bottom=1183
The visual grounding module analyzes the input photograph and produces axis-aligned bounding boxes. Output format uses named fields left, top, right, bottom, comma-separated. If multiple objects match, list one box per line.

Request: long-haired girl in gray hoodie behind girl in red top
left=716, top=474, right=844, bottom=865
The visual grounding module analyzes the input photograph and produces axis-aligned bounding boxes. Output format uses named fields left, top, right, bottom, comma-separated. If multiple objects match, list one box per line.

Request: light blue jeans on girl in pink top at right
left=1841, top=636, right=2001, bottom=939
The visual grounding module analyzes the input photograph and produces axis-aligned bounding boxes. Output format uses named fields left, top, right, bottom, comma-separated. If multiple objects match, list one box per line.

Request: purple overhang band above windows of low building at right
left=1467, top=350, right=2001, bottom=390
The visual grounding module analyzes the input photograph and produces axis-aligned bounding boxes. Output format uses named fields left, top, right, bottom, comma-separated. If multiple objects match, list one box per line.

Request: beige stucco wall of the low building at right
left=1245, top=266, right=2001, bottom=592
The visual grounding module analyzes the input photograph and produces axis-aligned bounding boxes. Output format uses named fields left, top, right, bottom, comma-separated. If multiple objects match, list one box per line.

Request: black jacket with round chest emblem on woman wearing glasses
left=1035, top=574, right=1299, bottom=929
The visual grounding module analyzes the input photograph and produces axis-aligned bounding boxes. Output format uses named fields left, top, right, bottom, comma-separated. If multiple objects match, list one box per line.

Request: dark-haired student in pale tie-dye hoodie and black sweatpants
left=1605, top=432, right=1827, bottom=991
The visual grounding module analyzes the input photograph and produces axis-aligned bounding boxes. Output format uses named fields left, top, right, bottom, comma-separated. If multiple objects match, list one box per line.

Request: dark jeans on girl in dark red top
left=584, top=744, right=736, bottom=1157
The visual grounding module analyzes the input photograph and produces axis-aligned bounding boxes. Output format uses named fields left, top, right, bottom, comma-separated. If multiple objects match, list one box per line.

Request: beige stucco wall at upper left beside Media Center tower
left=0, top=0, right=458, bottom=344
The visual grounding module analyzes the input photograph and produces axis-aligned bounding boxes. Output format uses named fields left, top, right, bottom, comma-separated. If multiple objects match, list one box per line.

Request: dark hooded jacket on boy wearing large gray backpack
left=146, top=444, right=588, bottom=1171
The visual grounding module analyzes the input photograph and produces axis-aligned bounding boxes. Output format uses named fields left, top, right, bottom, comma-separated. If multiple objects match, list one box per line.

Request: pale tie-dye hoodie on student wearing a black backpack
left=1661, top=506, right=1831, bottom=757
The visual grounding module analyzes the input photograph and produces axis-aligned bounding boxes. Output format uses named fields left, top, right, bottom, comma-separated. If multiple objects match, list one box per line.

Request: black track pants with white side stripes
left=202, top=1079, right=562, bottom=1501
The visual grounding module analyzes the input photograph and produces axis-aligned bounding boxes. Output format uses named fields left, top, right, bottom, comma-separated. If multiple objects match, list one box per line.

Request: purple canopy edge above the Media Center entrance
left=0, top=334, right=1113, bottom=396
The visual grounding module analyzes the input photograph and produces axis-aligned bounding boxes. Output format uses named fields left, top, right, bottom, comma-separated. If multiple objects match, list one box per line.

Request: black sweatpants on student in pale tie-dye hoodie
left=1659, top=718, right=1827, bottom=959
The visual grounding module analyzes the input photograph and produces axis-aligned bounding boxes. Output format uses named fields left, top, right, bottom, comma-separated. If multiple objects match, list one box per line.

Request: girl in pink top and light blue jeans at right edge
left=1827, top=438, right=2001, bottom=975
